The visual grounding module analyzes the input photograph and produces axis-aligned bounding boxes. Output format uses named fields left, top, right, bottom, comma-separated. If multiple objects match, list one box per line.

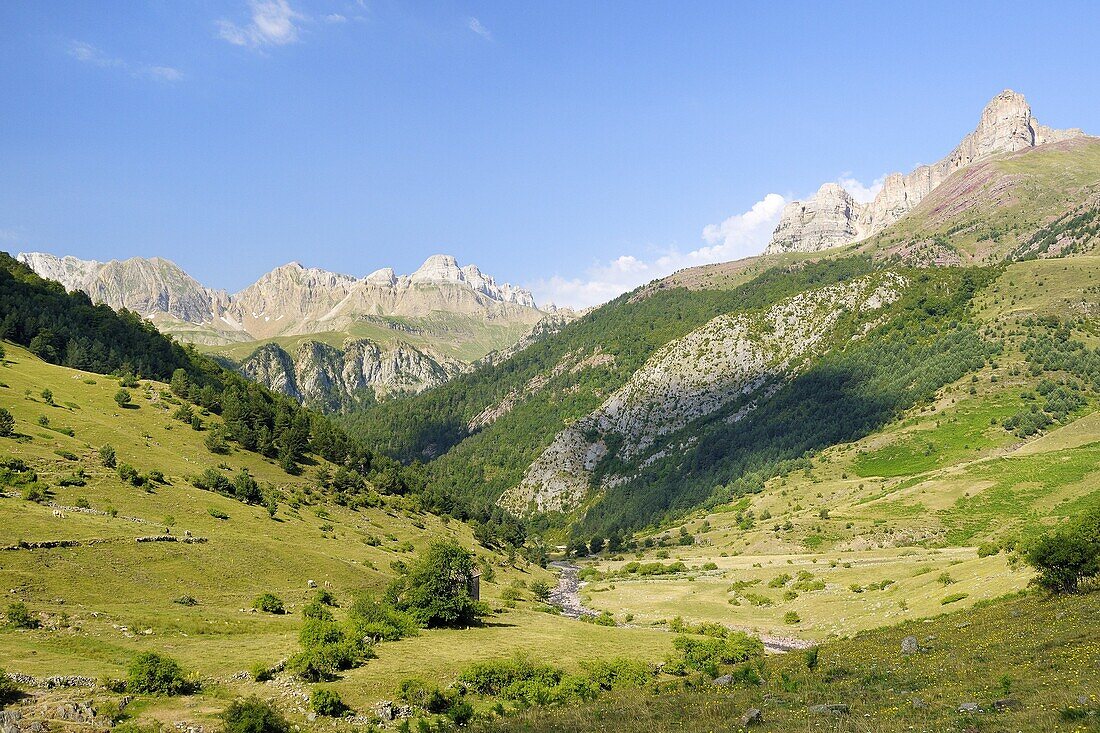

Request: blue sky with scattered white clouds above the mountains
left=0, top=0, right=1100, bottom=305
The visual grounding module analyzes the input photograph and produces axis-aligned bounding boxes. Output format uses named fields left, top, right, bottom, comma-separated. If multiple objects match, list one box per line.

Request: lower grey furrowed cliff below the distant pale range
left=241, top=339, right=469, bottom=411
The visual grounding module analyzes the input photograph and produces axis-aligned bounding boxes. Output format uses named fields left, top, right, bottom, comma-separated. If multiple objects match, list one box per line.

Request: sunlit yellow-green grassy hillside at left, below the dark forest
left=0, top=344, right=669, bottom=724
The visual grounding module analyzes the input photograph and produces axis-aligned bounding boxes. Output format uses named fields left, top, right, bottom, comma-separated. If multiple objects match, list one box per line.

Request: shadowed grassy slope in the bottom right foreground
left=475, top=593, right=1100, bottom=733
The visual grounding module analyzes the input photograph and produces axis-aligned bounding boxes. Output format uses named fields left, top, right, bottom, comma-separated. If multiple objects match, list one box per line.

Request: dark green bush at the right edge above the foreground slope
left=1026, top=506, right=1100, bottom=593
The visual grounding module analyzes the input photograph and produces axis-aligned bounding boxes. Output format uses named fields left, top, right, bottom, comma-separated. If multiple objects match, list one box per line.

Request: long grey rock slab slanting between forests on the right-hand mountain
left=501, top=273, right=908, bottom=514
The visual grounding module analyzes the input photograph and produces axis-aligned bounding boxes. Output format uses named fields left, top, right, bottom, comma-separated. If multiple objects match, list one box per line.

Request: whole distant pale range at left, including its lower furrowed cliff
left=18, top=252, right=554, bottom=409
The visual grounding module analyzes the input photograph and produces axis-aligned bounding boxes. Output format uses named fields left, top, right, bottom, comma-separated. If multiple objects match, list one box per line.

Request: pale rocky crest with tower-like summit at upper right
left=766, top=89, right=1085, bottom=254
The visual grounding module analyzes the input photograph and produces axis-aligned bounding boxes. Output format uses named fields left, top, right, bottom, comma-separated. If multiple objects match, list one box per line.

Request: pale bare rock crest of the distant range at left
left=18, top=252, right=542, bottom=342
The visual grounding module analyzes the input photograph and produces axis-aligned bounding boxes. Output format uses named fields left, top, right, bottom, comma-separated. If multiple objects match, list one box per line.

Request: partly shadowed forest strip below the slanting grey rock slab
left=575, top=269, right=1000, bottom=534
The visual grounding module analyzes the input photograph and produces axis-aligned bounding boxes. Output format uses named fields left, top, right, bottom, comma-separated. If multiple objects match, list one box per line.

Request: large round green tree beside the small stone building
left=386, top=540, right=486, bottom=626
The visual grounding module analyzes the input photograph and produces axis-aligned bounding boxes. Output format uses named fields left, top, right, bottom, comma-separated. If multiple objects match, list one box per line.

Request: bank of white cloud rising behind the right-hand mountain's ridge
left=529, top=194, right=787, bottom=308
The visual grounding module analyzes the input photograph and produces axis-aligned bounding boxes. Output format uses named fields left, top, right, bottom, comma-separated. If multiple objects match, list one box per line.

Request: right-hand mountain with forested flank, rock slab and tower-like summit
left=344, top=91, right=1100, bottom=536
